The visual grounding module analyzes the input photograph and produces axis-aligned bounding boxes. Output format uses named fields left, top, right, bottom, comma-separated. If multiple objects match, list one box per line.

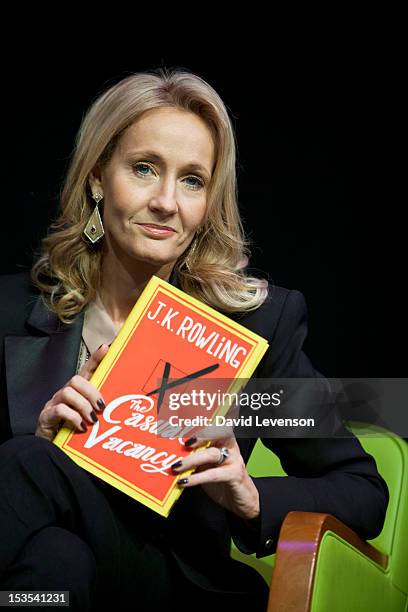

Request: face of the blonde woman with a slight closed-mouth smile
left=90, top=108, right=214, bottom=267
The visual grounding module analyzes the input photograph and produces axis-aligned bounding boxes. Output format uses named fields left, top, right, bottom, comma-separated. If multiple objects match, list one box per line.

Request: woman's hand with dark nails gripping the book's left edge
left=35, top=344, right=109, bottom=441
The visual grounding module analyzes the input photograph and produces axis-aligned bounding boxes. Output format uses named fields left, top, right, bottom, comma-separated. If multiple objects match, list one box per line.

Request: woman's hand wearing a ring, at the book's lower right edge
left=173, top=433, right=260, bottom=520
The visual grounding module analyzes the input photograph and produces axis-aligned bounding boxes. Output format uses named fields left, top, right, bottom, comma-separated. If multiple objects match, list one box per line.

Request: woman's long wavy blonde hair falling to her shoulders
left=31, top=68, right=268, bottom=323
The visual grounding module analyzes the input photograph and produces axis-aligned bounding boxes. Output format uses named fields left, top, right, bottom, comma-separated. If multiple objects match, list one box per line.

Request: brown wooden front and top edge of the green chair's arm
left=268, top=512, right=388, bottom=612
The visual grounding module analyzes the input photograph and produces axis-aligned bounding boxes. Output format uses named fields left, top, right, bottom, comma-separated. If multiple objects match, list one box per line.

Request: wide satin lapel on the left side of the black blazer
left=4, top=296, right=84, bottom=436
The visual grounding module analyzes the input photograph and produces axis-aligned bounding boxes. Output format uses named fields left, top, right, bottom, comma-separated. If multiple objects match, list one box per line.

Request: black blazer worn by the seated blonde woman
left=0, top=272, right=388, bottom=589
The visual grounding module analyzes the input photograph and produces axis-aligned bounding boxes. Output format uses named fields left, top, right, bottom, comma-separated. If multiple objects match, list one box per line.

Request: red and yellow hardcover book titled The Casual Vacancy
left=53, top=276, right=268, bottom=517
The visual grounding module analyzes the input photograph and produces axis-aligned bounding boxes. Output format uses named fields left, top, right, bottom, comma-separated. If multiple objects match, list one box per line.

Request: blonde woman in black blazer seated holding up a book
left=0, top=70, right=388, bottom=610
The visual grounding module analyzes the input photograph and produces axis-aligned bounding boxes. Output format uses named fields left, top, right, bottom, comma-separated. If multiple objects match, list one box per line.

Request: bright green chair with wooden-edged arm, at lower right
left=231, top=422, right=408, bottom=612
